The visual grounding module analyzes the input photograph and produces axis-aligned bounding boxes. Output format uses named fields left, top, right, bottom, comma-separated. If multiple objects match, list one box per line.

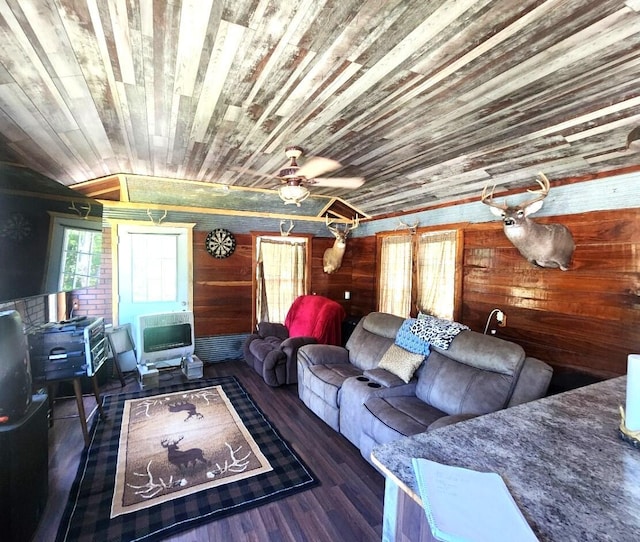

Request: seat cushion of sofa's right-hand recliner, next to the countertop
left=362, top=396, right=445, bottom=444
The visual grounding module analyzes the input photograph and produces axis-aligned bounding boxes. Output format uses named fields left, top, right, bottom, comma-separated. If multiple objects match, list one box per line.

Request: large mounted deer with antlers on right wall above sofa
left=481, top=173, right=575, bottom=271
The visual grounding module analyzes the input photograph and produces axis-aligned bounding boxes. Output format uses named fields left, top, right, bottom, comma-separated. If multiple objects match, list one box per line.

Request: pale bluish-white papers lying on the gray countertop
left=412, top=458, right=538, bottom=542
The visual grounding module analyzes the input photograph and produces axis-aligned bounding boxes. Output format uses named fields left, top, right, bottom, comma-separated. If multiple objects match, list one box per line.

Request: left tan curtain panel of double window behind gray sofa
left=378, top=234, right=411, bottom=318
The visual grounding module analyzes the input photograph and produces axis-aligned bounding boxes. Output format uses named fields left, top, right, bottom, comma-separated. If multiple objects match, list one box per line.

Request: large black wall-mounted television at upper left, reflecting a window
left=0, top=162, right=103, bottom=303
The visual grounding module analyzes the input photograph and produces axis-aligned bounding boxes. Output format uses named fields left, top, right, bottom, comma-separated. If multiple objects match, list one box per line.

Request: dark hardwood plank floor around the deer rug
left=33, top=361, right=384, bottom=542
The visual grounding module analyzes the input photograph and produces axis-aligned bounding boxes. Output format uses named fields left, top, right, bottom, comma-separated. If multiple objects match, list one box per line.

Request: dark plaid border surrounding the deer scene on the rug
left=56, top=377, right=318, bottom=542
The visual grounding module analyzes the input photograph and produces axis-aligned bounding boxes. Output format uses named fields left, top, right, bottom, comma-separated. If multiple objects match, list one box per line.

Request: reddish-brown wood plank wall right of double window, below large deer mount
left=461, top=209, right=640, bottom=377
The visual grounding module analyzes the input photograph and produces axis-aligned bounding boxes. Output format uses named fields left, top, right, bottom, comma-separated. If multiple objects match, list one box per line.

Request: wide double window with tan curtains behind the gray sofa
left=378, top=230, right=460, bottom=320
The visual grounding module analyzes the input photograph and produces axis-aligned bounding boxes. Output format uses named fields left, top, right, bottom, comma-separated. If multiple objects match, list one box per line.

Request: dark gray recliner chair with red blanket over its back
left=243, top=295, right=346, bottom=387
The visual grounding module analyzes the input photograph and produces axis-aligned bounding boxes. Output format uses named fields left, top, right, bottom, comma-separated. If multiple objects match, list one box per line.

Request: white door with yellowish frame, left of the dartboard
left=115, top=224, right=193, bottom=330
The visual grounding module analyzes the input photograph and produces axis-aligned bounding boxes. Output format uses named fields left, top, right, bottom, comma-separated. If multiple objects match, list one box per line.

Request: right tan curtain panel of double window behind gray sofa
left=417, top=231, right=456, bottom=320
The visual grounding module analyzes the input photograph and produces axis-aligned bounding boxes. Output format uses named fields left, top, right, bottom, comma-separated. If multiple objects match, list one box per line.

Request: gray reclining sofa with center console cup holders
left=297, top=312, right=552, bottom=461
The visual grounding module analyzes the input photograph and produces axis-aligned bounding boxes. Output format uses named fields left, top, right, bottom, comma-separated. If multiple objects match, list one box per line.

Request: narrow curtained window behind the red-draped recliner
left=256, top=236, right=307, bottom=324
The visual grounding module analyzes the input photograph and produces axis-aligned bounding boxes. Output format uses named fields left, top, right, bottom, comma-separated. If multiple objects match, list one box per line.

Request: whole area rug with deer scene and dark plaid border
left=57, top=377, right=317, bottom=542
